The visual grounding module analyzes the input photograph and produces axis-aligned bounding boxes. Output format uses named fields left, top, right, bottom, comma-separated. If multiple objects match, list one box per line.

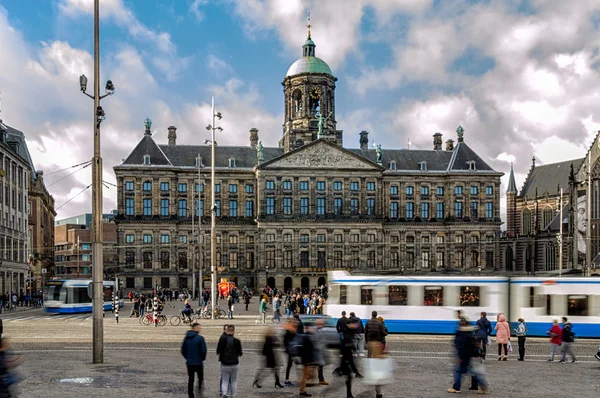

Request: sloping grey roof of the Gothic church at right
left=519, top=158, right=583, bottom=198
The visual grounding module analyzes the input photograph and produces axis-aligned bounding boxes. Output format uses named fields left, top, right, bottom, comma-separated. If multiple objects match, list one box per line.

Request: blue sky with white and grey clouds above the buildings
left=0, top=0, right=600, bottom=219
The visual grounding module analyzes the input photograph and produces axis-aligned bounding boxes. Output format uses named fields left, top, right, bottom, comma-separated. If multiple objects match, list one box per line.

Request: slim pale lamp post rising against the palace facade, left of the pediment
left=204, top=97, right=223, bottom=319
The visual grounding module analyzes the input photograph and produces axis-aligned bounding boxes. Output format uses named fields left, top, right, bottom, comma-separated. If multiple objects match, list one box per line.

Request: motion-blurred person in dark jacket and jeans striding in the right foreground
left=448, top=317, right=488, bottom=394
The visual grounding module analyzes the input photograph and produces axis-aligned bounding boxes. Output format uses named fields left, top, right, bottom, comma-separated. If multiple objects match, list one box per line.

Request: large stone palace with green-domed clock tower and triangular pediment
left=114, top=28, right=503, bottom=290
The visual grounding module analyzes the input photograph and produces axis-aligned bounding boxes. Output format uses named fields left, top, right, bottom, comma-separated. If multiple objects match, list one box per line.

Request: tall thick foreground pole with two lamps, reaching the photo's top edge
left=79, top=0, right=115, bottom=363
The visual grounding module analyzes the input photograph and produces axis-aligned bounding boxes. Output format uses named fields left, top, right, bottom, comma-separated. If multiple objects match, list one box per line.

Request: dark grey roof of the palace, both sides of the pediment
left=116, top=135, right=495, bottom=172
